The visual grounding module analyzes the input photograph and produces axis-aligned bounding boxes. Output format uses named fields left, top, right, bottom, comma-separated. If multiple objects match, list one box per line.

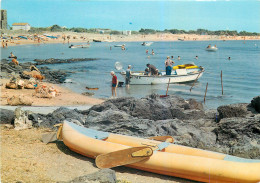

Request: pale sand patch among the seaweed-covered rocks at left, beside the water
left=0, top=79, right=104, bottom=106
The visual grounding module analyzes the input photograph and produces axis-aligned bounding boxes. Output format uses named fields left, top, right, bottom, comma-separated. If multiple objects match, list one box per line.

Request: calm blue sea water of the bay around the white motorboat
left=1, top=41, right=260, bottom=108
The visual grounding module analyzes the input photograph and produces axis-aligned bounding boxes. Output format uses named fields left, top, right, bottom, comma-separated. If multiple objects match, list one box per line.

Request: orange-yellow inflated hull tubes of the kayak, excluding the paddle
left=61, top=122, right=260, bottom=183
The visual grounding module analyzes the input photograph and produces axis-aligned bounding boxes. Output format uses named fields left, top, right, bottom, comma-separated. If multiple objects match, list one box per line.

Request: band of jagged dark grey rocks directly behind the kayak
left=1, top=95, right=260, bottom=159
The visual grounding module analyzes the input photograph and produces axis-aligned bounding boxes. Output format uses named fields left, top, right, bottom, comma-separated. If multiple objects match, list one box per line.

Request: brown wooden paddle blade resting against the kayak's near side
left=95, top=146, right=153, bottom=168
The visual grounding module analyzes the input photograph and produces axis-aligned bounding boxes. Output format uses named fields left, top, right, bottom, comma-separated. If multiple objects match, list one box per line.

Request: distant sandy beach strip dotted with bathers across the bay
left=1, top=32, right=260, bottom=47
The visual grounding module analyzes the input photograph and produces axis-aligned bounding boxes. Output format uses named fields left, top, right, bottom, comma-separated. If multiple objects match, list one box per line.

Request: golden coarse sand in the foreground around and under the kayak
left=1, top=125, right=194, bottom=183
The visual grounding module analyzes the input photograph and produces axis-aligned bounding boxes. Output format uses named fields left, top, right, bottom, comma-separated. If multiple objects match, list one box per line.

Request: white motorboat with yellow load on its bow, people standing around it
left=120, top=64, right=204, bottom=85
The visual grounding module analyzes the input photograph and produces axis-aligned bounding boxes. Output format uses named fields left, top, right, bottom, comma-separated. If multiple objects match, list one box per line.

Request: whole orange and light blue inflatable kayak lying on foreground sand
left=50, top=121, right=260, bottom=183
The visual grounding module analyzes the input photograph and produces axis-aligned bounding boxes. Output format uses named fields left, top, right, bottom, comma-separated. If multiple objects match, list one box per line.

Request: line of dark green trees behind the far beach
left=27, top=25, right=260, bottom=36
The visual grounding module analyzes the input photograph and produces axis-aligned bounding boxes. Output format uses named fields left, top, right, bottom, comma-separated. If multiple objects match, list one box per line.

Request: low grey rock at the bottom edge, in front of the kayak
left=59, top=168, right=117, bottom=183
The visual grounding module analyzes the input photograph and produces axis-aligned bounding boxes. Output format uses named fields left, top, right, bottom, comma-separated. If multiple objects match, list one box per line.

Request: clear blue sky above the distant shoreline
left=0, top=0, right=260, bottom=33
